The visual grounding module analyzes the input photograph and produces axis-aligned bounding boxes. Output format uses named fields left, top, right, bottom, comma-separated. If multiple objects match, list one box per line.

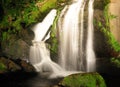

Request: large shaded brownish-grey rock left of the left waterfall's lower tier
left=2, top=38, right=29, bottom=59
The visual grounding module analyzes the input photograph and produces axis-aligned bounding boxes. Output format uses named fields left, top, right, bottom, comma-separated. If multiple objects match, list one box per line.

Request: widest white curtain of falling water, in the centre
left=58, top=0, right=84, bottom=70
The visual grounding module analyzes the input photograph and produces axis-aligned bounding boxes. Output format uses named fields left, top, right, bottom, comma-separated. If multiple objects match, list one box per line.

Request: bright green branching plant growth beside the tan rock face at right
left=98, top=5, right=120, bottom=52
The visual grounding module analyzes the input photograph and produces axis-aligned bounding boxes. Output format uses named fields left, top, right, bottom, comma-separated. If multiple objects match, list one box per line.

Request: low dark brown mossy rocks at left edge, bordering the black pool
left=0, top=57, right=35, bottom=73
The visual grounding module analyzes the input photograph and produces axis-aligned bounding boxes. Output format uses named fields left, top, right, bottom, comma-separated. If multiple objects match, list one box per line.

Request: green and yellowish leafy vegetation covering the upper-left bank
left=0, top=0, right=66, bottom=40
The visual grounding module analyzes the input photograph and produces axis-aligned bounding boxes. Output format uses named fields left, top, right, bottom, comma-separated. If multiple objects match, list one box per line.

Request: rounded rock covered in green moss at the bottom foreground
left=59, top=73, right=106, bottom=87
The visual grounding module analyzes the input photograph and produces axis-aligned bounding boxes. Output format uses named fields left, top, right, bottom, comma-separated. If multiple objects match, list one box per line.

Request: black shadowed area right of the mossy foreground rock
left=96, top=58, right=120, bottom=87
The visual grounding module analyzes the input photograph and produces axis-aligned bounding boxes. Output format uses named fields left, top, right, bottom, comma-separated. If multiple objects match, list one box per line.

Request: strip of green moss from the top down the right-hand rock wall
left=94, top=0, right=120, bottom=52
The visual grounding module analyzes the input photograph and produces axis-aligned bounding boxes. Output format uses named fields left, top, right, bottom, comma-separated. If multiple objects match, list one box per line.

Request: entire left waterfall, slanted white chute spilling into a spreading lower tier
left=29, top=9, right=80, bottom=78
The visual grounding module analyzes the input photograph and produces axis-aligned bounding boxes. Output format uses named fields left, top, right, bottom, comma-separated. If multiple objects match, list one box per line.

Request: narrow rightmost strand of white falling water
left=86, top=0, right=96, bottom=72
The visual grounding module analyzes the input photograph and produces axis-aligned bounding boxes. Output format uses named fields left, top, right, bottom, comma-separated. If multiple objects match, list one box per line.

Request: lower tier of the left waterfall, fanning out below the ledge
left=30, top=41, right=63, bottom=73
